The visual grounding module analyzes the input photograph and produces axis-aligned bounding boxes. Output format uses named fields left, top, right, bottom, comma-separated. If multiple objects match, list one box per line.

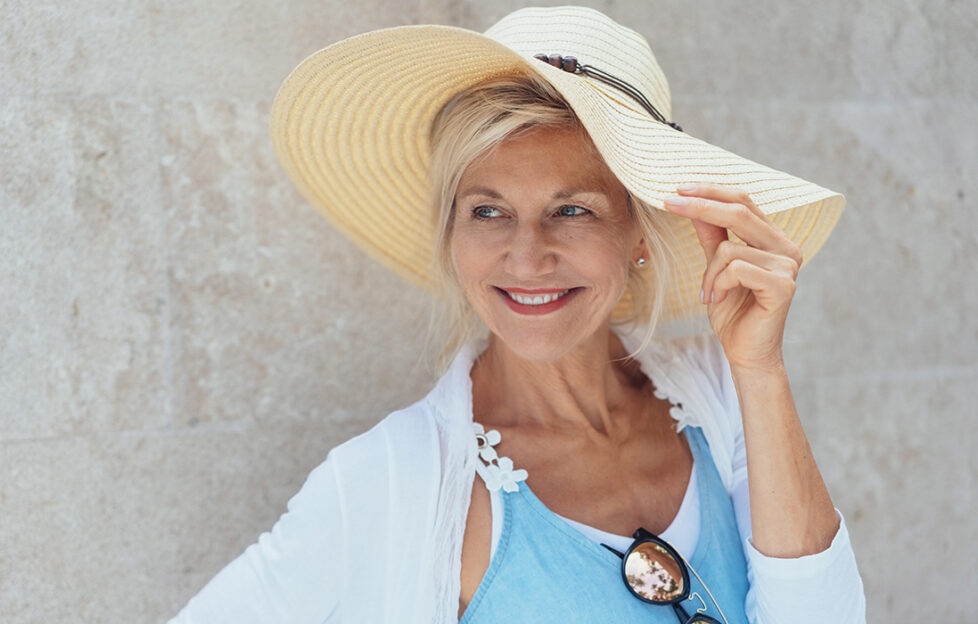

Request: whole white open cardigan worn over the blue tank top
left=170, top=333, right=865, bottom=624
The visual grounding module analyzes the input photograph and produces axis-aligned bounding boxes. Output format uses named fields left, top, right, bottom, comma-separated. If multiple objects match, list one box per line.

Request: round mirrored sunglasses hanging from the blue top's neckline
left=602, top=528, right=727, bottom=624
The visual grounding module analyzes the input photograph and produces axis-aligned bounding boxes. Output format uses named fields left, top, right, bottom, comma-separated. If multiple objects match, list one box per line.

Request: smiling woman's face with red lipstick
left=451, top=127, right=644, bottom=361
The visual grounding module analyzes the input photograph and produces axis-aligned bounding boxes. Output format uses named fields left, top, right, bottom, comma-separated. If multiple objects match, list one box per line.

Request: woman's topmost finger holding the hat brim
left=665, top=195, right=801, bottom=264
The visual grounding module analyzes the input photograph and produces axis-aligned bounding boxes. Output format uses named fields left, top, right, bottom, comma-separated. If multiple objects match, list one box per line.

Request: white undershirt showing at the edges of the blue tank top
left=489, top=460, right=700, bottom=561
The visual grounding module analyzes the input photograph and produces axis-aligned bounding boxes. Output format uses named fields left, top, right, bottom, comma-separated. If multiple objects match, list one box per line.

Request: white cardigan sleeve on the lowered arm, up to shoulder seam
left=170, top=454, right=346, bottom=624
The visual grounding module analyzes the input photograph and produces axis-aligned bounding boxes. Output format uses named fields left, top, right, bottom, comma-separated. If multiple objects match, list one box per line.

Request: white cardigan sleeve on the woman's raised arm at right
left=684, top=335, right=866, bottom=624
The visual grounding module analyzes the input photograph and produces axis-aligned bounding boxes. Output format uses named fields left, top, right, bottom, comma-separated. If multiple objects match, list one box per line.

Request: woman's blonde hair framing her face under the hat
left=429, top=75, right=677, bottom=371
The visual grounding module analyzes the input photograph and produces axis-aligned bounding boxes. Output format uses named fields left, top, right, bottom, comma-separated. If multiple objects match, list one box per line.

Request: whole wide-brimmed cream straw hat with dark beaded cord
left=271, top=7, right=845, bottom=318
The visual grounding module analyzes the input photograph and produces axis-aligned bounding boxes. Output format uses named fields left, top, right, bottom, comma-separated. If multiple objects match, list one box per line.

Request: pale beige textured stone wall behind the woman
left=0, top=0, right=978, bottom=624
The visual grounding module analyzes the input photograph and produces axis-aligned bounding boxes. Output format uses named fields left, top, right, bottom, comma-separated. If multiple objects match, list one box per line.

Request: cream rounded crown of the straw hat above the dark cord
left=484, top=6, right=672, bottom=119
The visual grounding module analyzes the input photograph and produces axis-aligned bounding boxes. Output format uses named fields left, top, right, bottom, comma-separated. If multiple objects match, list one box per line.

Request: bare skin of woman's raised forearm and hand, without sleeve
left=666, top=184, right=838, bottom=557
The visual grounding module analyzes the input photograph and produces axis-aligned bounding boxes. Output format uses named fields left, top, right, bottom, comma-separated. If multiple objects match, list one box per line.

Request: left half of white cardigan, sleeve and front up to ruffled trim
left=170, top=405, right=441, bottom=624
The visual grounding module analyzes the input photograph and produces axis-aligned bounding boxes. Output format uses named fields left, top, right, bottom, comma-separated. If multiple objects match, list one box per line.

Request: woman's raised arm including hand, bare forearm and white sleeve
left=666, top=185, right=865, bottom=623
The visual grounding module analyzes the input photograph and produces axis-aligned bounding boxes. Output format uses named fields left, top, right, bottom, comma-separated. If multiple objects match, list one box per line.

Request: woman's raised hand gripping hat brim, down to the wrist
left=665, top=184, right=802, bottom=370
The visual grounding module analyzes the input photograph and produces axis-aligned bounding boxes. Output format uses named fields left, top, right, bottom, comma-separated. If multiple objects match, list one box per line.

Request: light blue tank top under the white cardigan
left=460, top=427, right=747, bottom=624
